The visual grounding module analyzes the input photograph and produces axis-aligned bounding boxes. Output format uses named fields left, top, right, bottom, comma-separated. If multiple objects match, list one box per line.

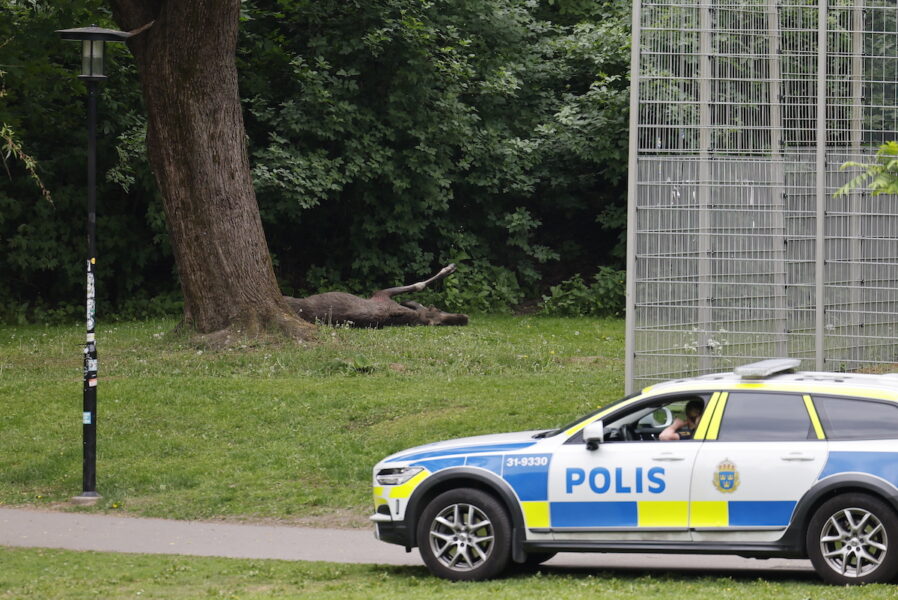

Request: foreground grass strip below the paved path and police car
left=0, top=548, right=895, bottom=600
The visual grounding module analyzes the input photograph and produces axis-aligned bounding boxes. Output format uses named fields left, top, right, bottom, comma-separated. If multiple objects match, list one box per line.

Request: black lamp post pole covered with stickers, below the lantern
left=81, top=80, right=99, bottom=498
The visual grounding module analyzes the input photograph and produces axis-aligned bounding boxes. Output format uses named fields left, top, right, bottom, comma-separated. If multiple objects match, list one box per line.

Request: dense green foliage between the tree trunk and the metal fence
left=240, top=0, right=629, bottom=302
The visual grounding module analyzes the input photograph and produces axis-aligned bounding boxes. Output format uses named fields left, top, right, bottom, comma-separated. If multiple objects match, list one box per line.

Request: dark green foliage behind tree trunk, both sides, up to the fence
left=0, top=0, right=629, bottom=319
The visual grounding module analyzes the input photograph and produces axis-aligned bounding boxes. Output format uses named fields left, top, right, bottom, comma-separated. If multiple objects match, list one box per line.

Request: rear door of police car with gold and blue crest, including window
left=689, top=391, right=827, bottom=541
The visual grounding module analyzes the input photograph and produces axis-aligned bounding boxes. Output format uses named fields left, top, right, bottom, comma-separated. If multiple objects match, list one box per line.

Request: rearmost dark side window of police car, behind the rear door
left=814, top=396, right=898, bottom=440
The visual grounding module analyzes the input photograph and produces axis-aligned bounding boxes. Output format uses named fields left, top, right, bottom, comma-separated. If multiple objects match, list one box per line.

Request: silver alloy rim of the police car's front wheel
left=429, top=504, right=495, bottom=571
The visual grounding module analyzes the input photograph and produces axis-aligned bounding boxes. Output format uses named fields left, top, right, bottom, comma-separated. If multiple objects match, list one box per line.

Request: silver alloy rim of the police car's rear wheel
left=820, top=508, right=889, bottom=578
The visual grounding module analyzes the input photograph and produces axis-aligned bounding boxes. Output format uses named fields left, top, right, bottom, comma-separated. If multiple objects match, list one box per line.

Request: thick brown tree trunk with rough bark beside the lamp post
left=111, top=0, right=314, bottom=343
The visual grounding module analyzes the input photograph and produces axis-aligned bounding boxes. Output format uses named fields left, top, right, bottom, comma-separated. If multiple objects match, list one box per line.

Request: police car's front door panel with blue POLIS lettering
left=548, top=396, right=707, bottom=541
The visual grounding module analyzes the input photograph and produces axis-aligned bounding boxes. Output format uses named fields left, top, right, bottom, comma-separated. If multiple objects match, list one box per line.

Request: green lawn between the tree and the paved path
left=0, top=316, right=624, bottom=526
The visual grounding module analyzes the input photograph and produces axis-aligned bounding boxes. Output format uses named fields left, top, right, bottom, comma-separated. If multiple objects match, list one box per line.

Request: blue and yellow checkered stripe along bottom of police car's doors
left=521, top=500, right=795, bottom=529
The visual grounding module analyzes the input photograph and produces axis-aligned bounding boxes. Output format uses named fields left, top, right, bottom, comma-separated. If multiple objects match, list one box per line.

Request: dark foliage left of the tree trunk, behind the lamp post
left=0, top=0, right=177, bottom=321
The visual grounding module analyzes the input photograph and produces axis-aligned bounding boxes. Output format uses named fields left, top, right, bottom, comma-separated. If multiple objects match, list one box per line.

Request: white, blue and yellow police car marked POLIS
left=371, top=359, right=898, bottom=584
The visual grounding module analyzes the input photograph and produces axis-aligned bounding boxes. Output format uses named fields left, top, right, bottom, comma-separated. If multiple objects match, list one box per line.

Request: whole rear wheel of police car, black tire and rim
left=806, top=494, right=898, bottom=585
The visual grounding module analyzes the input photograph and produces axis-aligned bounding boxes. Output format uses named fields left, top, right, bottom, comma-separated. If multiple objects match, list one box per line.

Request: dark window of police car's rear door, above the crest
left=717, top=392, right=817, bottom=442
